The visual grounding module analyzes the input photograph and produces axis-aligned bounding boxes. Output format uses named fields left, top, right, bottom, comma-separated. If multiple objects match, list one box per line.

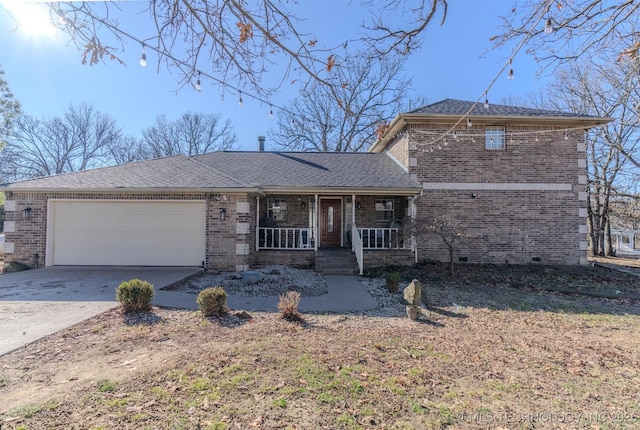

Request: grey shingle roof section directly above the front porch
left=194, top=151, right=420, bottom=188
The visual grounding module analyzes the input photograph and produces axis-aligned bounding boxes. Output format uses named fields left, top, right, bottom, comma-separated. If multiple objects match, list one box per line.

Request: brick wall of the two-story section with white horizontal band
left=389, top=123, right=586, bottom=264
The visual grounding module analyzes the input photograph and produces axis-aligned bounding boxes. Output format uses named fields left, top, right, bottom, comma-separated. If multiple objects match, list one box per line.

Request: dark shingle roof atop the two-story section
left=408, top=99, right=595, bottom=118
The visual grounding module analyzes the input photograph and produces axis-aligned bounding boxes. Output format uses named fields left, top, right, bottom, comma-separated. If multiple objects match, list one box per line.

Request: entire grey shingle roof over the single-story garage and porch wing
left=2, top=152, right=420, bottom=191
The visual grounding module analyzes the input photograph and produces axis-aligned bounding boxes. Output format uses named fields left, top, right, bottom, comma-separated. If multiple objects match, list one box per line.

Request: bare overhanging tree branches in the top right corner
left=493, top=0, right=640, bottom=76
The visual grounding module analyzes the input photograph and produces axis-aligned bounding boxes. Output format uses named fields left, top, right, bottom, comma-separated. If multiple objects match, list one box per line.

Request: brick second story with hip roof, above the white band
left=370, top=99, right=611, bottom=184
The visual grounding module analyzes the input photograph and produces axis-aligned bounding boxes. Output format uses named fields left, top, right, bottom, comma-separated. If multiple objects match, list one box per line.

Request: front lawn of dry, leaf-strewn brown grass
left=0, top=265, right=640, bottom=430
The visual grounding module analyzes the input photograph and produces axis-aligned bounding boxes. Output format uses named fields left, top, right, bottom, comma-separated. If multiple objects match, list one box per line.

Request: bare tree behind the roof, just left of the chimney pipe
left=142, top=112, right=237, bottom=158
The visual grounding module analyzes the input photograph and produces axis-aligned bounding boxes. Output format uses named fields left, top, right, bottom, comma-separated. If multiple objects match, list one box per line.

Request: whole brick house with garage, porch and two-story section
left=0, top=100, right=609, bottom=272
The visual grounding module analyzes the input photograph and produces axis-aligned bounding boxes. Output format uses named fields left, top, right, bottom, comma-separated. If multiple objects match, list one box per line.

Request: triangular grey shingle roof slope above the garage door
left=2, top=155, right=249, bottom=190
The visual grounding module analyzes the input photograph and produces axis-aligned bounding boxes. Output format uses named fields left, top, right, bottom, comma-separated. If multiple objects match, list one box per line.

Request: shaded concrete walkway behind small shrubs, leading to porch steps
left=153, top=276, right=378, bottom=313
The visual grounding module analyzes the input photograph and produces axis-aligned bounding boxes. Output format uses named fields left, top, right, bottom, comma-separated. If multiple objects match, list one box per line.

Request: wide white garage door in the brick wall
left=47, top=200, right=206, bottom=266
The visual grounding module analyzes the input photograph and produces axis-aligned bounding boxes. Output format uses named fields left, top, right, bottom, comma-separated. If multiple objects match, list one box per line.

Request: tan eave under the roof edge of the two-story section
left=368, top=113, right=614, bottom=152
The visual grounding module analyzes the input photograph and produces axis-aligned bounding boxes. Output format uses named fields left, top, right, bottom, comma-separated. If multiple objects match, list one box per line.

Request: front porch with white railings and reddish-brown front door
left=254, top=194, right=415, bottom=274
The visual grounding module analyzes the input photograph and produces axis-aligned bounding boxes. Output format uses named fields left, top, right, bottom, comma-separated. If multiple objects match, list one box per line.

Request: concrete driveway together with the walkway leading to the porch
left=0, top=267, right=378, bottom=355
